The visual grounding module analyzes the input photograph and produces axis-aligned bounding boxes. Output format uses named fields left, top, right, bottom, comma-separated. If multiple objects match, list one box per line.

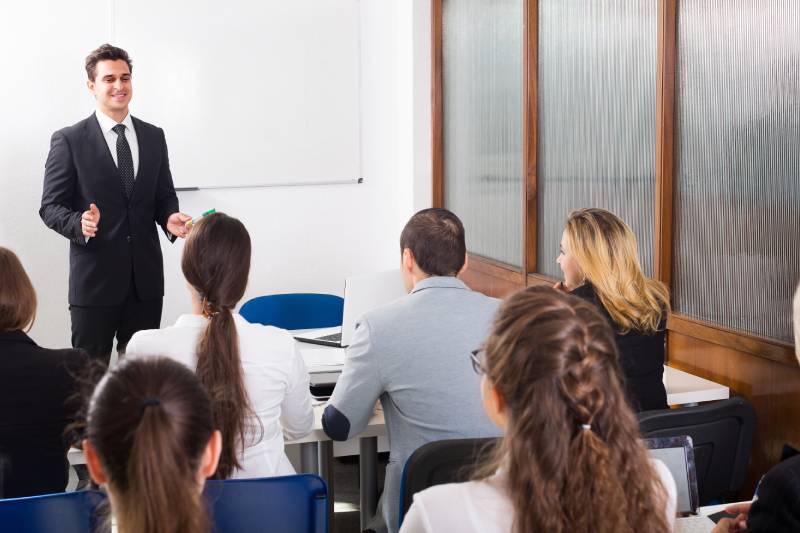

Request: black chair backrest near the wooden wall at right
left=638, top=397, right=756, bottom=505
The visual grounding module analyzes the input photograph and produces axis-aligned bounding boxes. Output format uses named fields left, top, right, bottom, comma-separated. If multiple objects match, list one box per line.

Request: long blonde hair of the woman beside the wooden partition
left=565, top=208, right=669, bottom=334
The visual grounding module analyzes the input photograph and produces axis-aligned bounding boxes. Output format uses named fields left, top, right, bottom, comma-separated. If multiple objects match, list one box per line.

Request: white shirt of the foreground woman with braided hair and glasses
left=400, top=459, right=678, bottom=533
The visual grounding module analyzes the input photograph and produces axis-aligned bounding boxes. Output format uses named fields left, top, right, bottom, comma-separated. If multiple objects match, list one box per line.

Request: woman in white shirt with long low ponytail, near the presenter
left=127, top=213, right=314, bottom=479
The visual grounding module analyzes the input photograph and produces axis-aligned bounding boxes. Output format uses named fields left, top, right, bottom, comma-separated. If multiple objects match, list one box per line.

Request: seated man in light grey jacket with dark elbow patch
left=322, top=209, right=499, bottom=531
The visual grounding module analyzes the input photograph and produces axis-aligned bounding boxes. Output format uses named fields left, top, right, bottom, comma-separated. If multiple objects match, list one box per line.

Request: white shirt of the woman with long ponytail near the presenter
left=126, top=314, right=314, bottom=478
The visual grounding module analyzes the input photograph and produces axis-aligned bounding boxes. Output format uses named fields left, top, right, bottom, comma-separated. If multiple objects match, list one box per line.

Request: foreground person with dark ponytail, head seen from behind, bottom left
left=83, top=357, right=222, bottom=533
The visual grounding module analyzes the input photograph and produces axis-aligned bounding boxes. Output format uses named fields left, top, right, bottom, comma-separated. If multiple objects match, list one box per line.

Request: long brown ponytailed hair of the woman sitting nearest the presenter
left=181, top=213, right=255, bottom=479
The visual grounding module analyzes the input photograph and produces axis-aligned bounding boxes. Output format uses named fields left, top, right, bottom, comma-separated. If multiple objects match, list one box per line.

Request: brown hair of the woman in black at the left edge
left=0, top=246, right=36, bottom=331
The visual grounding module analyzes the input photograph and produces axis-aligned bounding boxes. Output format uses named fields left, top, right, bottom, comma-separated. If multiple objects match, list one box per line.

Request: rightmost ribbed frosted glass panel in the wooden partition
left=674, top=0, right=800, bottom=341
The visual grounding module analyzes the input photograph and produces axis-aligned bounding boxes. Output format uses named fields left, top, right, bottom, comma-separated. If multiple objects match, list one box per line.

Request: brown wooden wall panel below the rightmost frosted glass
left=667, top=331, right=800, bottom=492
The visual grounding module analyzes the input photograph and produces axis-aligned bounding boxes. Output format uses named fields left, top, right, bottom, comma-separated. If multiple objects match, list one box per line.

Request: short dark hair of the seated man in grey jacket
left=400, top=207, right=467, bottom=276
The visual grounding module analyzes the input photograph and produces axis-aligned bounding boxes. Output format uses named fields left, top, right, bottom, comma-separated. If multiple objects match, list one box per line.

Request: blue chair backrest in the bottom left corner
left=0, top=490, right=109, bottom=533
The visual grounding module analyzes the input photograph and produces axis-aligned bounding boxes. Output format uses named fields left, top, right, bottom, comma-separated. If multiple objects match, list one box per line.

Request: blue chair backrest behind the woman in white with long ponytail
left=205, top=474, right=328, bottom=533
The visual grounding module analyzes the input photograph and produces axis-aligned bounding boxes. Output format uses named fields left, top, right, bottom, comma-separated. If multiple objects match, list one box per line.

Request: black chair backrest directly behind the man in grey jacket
left=400, top=438, right=499, bottom=525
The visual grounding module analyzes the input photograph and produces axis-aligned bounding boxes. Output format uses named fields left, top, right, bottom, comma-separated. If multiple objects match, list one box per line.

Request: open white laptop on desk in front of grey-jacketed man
left=295, top=269, right=406, bottom=348
